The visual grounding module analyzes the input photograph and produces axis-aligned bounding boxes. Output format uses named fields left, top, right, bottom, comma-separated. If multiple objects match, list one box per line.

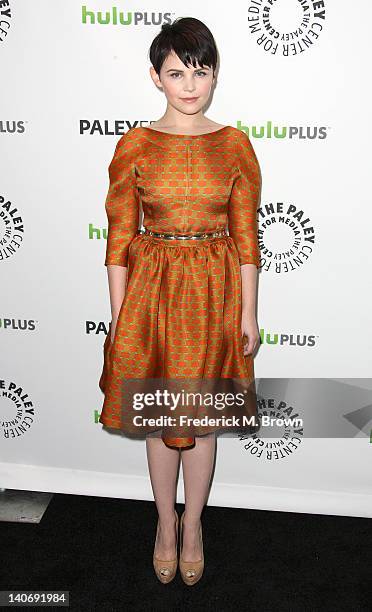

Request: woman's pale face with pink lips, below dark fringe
left=150, top=51, right=214, bottom=115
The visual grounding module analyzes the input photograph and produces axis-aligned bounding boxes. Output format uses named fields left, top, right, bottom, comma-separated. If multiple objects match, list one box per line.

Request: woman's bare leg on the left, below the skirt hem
left=146, top=437, right=180, bottom=561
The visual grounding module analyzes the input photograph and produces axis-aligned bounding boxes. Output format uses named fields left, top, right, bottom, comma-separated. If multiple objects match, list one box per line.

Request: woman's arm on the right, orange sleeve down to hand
left=229, top=132, right=262, bottom=355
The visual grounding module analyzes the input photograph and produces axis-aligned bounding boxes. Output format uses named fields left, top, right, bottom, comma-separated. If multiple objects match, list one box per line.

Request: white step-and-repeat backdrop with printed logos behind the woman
left=0, top=0, right=372, bottom=516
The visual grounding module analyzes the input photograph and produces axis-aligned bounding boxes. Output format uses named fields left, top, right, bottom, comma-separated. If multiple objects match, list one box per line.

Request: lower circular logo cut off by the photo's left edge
left=0, top=379, right=35, bottom=440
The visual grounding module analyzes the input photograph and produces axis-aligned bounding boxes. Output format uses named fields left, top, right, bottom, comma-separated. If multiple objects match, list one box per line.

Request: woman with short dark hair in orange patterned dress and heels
left=100, top=18, right=261, bottom=585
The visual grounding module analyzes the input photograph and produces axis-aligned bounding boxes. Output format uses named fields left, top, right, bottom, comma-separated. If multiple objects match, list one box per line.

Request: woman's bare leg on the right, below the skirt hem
left=181, top=433, right=216, bottom=561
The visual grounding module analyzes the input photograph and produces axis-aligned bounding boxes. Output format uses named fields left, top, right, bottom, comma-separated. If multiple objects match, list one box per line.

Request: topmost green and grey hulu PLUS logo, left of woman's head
left=81, top=5, right=172, bottom=26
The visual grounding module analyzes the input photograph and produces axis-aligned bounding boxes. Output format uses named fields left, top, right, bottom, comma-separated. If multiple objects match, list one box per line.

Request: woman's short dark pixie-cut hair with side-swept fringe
left=149, top=17, right=218, bottom=76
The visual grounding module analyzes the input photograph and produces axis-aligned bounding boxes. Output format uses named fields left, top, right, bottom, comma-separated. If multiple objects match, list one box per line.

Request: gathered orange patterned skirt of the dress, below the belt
left=99, top=234, right=258, bottom=448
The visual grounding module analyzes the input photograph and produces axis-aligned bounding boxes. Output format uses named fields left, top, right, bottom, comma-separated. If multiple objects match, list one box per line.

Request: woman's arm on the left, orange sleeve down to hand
left=105, top=134, right=140, bottom=340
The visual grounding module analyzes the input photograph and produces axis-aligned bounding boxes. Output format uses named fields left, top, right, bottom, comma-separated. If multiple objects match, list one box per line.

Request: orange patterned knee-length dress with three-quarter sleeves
left=99, top=126, right=261, bottom=448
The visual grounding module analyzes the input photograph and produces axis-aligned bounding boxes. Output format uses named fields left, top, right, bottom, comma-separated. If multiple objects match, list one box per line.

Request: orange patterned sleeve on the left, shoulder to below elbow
left=105, top=133, right=140, bottom=268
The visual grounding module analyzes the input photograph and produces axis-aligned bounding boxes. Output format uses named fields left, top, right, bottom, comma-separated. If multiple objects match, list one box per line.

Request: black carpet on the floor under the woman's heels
left=0, top=494, right=372, bottom=612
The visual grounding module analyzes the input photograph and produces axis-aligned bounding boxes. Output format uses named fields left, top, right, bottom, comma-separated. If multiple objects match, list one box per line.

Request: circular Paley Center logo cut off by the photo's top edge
left=248, top=0, right=325, bottom=57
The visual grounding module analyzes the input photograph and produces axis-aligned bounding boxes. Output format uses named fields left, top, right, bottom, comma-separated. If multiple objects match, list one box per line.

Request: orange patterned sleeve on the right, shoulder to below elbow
left=228, top=130, right=261, bottom=268
